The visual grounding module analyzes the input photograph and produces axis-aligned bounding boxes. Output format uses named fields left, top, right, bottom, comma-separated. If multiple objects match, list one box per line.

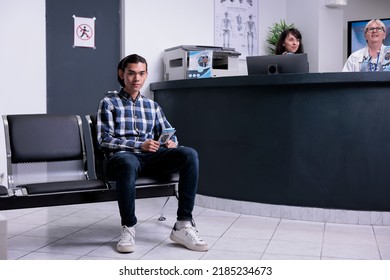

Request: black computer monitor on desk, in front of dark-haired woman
left=246, top=53, right=309, bottom=75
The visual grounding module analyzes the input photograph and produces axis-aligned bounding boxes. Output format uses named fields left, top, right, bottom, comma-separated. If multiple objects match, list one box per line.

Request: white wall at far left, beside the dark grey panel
left=0, top=0, right=46, bottom=183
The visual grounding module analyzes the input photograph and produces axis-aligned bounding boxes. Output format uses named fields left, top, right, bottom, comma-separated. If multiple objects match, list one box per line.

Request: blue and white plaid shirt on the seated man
left=97, top=89, right=177, bottom=153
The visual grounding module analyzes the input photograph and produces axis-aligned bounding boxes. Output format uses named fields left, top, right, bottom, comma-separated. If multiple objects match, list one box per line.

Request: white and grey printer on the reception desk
left=164, top=45, right=241, bottom=81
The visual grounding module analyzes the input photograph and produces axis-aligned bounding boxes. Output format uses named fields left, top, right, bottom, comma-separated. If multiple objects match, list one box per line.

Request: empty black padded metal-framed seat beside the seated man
left=3, top=114, right=108, bottom=196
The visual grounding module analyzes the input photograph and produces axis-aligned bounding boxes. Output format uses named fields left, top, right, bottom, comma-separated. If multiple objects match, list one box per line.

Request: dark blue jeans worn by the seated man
left=107, top=146, right=199, bottom=227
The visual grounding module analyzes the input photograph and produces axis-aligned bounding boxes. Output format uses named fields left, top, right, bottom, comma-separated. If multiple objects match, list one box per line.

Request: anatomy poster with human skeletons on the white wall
left=214, top=0, right=259, bottom=59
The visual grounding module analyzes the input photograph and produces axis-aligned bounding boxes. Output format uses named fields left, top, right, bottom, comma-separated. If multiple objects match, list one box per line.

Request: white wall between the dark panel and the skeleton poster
left=122, top=0, right=214, bottom=98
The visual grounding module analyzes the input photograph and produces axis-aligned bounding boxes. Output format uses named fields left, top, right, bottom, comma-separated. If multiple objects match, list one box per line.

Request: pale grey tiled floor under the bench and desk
left=0, top=198, right=390, bottom=260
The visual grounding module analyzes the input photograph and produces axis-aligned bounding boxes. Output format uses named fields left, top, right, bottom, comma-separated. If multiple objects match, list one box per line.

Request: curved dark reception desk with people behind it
left=150, top=72, right=390, bottom=211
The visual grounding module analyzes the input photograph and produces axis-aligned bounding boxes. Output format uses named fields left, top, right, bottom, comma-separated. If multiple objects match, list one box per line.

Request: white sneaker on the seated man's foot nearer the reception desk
left=170, top=225, right=209, bottom=251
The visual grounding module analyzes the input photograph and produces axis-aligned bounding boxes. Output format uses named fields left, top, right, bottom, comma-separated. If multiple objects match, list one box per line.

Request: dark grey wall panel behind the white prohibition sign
left=46, top=0, right=120, bottom=115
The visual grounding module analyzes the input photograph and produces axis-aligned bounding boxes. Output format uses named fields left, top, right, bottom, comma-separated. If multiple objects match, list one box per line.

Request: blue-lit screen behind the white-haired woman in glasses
left=347, top=18, right=390, bottom=56
